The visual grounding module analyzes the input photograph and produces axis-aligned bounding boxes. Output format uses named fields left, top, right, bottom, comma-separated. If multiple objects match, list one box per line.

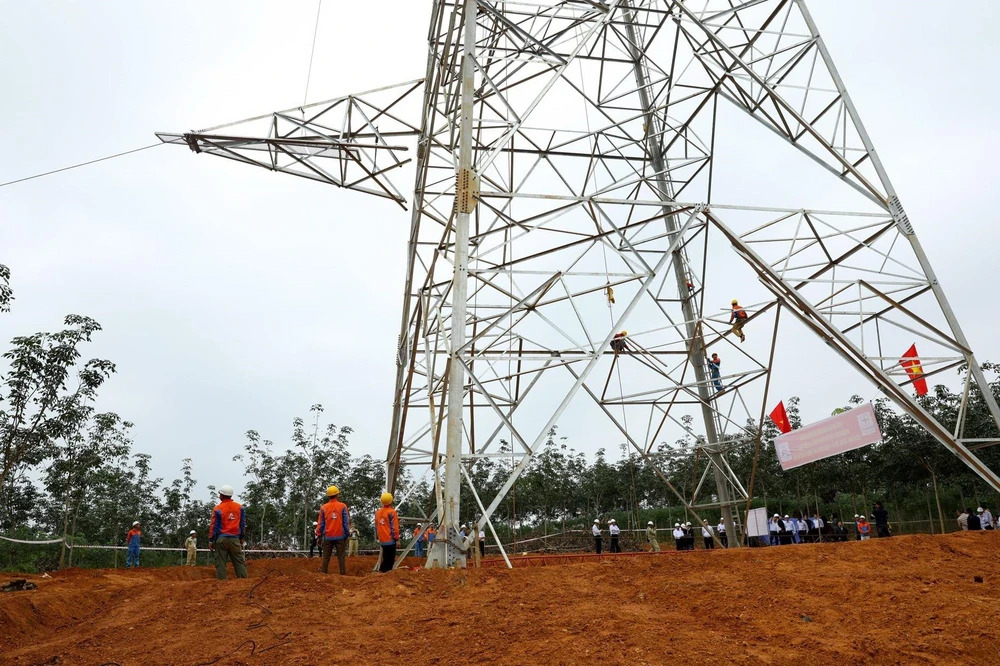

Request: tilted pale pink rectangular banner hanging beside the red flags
left=774, top=402, right=882, bottom=469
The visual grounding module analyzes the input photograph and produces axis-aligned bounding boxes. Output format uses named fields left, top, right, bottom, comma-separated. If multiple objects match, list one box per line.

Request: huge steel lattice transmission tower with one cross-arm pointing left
left=160, top=0, right=1000, bottom=566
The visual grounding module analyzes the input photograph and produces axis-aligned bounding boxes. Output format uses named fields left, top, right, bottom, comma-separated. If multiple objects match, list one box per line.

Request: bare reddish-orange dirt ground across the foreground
left=0, top=532, right=1000, bottom=666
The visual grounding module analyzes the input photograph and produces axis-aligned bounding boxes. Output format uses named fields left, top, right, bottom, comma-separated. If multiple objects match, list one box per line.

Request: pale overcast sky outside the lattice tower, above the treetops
left=0, top=0, right=1000, bottom=498
